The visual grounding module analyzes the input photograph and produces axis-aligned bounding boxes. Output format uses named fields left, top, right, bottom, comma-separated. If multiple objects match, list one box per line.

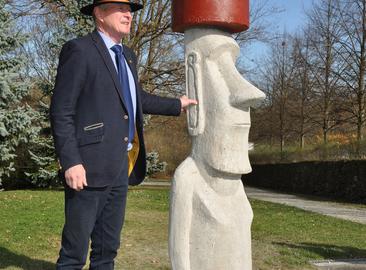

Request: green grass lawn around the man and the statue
left=0, top=188, right=366, bottom=270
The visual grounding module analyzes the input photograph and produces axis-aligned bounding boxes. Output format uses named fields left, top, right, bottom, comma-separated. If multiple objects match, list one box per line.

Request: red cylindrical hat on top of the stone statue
left=172, top=0, right=249, bottom=33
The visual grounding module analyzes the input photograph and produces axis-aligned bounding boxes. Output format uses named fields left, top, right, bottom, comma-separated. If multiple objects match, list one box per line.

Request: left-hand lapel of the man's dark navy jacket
left=91, top=30, right=127, bottom=108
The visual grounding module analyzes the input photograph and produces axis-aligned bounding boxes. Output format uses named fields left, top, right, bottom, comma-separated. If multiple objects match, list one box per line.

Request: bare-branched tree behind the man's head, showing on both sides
left=33, top=0, right=184, bottom=96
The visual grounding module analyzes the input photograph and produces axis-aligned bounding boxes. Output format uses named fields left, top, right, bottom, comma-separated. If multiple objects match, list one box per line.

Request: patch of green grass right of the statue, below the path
left=252, top=201, right=366, bottom=269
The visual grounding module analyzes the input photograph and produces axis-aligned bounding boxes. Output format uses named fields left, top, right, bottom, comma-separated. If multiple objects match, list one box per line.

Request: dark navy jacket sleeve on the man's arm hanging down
left=50, top=41, right=87, bottom=171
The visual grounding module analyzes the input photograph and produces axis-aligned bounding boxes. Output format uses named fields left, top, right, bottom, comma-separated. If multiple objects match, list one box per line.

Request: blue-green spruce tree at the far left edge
left=0, top=0, right=39, bottom=188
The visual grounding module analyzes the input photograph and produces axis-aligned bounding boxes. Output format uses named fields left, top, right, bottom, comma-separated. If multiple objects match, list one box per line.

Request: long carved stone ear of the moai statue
left=186, top=51, right=205, bottom=136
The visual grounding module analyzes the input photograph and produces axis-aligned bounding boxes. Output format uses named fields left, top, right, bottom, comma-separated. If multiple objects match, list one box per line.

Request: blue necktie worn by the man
left=111, top=45, right=135, bottom=143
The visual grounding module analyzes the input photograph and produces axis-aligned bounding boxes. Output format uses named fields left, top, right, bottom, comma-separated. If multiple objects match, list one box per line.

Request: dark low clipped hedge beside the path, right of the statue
left=242, top=160, right=366, bottom=203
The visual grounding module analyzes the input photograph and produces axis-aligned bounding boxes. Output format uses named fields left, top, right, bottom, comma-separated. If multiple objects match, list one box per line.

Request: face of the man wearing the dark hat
left=95, top=3, right=132, bottom=37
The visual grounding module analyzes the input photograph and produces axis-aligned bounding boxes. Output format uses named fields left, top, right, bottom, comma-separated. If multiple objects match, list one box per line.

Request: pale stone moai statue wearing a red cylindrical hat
left=169, top=0, right=264, bottom=270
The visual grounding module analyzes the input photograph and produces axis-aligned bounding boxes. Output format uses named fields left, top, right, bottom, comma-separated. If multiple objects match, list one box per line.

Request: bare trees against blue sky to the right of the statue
left=251, top=0, right=366, bottom=161
